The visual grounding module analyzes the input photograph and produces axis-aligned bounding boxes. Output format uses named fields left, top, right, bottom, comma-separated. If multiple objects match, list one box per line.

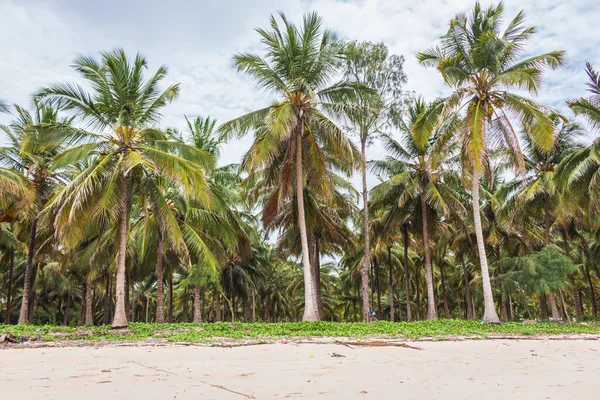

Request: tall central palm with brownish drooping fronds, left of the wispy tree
left=221, top=13, right=360, bottom=321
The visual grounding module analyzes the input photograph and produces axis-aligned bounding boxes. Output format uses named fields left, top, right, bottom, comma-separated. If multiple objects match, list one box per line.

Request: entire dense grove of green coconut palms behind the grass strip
left=0, top=4, right=600, bottom=327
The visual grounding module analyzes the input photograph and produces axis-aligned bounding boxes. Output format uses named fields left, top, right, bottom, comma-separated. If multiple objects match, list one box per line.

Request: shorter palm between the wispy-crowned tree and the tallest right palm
left=372, top=99, right=462, bottom=319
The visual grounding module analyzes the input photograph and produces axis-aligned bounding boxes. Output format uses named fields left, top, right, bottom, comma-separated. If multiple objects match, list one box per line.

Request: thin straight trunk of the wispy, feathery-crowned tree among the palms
left=360, top=135, right=371, bottom=321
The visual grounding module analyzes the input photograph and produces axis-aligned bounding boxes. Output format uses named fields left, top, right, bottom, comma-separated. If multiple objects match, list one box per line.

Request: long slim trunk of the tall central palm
left=296, top=117, right=321, bottom=321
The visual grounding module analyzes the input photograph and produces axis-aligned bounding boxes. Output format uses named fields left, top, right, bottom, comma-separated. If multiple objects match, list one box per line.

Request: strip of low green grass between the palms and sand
left=0, top=320, right=600, bottom=342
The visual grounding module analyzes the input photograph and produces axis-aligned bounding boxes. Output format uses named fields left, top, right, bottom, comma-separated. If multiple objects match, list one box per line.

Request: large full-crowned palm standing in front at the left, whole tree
left=36, top=49, right=214, bottom=328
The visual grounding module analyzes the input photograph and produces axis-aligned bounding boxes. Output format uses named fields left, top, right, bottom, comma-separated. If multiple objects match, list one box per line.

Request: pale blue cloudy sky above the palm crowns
left=0, top=0, right=600, bottom=188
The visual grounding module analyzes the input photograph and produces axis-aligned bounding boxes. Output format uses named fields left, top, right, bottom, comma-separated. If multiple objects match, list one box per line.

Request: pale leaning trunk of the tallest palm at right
left=472, top=166, right=500, bottom=324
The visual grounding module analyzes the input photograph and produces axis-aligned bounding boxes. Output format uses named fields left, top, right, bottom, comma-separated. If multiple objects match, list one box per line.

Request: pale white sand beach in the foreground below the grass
left=0, top=340, right=600, bottom=400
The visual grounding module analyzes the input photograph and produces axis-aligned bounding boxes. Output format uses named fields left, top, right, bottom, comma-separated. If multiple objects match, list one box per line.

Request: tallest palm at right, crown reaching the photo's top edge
left=417, top=3, right=564, bottom=323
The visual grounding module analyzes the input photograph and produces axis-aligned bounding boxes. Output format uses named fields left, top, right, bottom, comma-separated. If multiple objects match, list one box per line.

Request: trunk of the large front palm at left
left=112, top=174, right=129, bottom=328
